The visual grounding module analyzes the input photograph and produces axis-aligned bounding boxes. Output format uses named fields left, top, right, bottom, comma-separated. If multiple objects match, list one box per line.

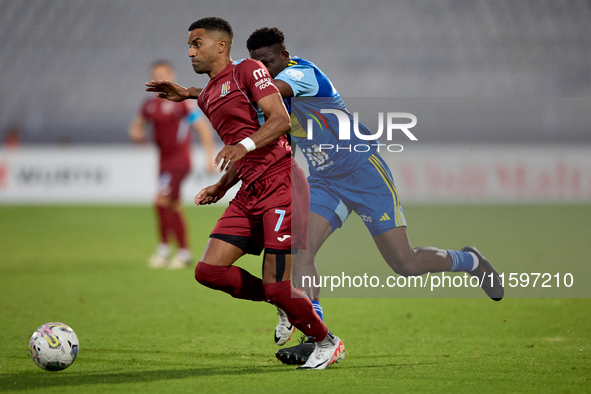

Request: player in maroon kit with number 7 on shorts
left=148, top=18, right=345, bottom=369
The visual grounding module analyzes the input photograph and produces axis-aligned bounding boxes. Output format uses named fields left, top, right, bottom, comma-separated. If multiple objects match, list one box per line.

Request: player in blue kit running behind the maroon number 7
left=246, top=28, right=504, bottom=364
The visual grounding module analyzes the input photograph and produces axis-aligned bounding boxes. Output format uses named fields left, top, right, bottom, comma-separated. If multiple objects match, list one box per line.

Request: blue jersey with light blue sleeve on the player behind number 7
left=275, top=57, right=375, bottom=178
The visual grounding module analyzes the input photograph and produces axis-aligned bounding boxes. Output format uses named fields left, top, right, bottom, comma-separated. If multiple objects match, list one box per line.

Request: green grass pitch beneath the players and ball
left=0, top=206, right=591, bottom=393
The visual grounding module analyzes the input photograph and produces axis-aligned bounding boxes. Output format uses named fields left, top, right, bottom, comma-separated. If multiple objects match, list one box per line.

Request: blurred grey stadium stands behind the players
left=0, top=0, right=591, bottom=143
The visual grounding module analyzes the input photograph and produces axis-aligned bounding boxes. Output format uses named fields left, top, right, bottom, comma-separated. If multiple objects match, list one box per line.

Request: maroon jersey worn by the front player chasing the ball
left=197, top=59, right=291, bottom=186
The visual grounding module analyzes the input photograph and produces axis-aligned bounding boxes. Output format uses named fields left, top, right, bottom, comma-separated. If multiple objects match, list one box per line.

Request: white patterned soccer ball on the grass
left=29, top=322, right=79, bottom=371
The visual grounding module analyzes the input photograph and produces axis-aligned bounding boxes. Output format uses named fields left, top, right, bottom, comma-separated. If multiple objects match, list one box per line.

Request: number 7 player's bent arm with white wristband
left=214, top=93, right=291, bottom=172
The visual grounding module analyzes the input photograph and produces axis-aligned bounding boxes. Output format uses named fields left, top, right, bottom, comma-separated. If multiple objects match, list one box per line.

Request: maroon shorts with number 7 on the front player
left=210, top=161, right=310, bottom=255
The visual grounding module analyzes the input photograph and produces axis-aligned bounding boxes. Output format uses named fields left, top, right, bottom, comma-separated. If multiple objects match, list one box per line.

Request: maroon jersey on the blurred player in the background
left=140, top=97, right=196, bottom=171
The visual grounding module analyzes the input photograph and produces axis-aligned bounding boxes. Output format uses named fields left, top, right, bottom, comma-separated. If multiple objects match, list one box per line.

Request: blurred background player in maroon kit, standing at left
left=129, top=61, right=215, bottom=269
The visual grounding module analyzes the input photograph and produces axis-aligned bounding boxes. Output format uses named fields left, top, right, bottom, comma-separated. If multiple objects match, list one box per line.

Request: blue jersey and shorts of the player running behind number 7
left=253, top=57, right=406, bottom=237
